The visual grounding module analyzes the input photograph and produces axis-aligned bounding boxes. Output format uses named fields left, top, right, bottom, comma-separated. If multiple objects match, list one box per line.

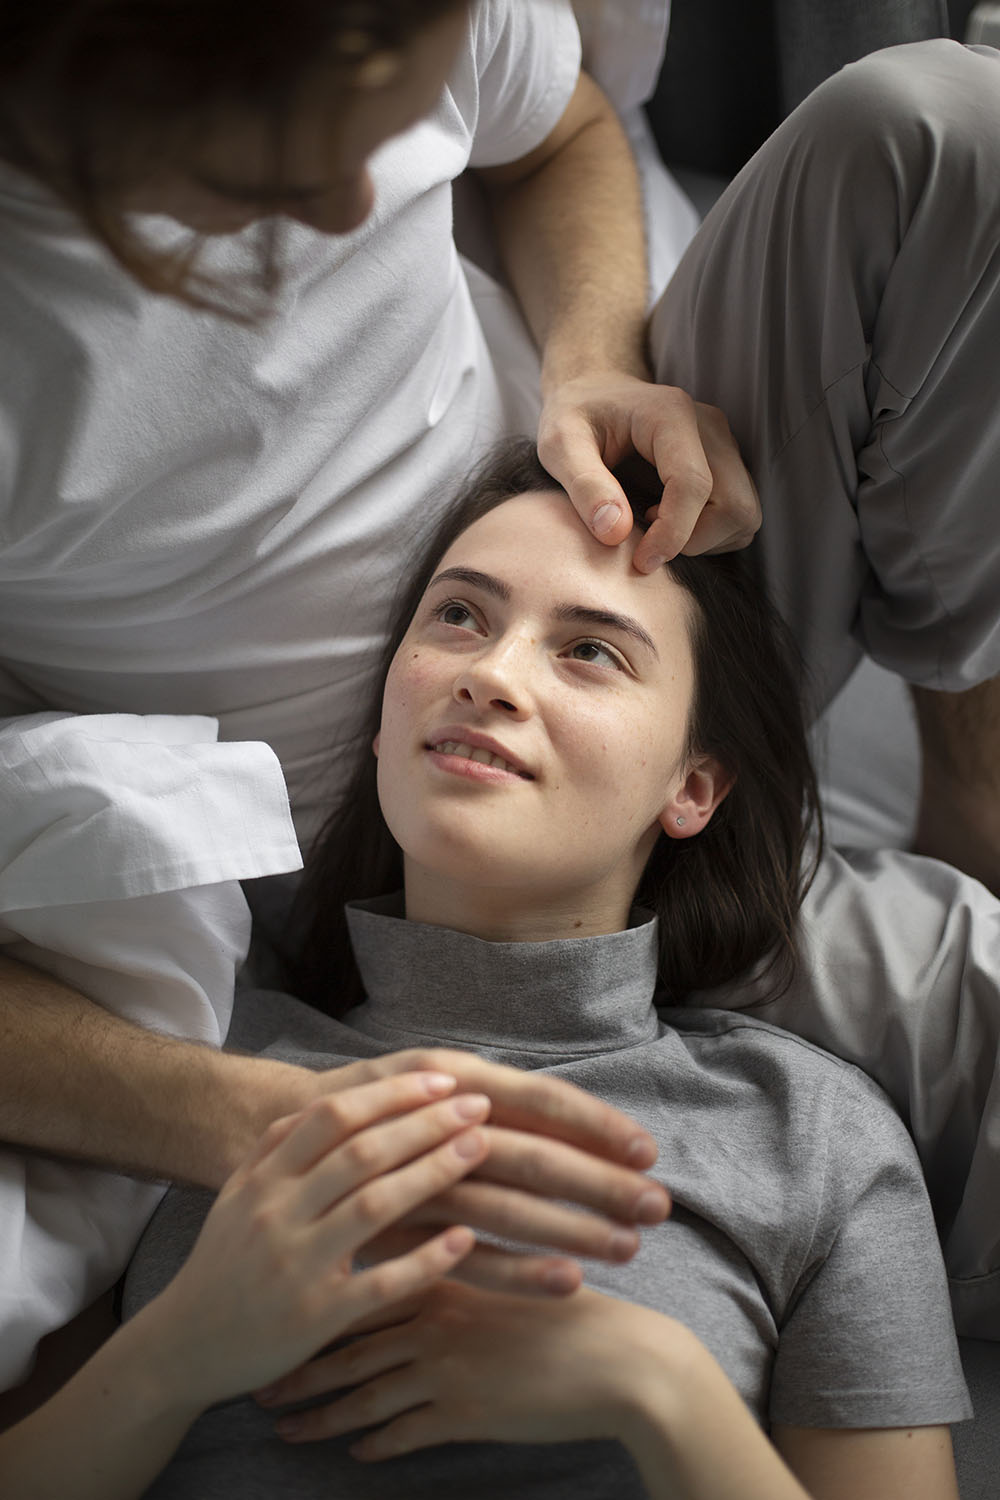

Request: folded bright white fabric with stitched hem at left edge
left=0, top=713, right=300, bottom=914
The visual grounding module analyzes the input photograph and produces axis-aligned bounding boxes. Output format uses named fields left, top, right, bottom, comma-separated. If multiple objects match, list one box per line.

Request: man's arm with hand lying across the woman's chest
left=0, top=957, right=669, bottom=1293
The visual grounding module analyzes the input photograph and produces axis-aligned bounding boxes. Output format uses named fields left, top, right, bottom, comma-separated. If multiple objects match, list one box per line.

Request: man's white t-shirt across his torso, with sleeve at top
left=0, top=0, right=580, bottom=839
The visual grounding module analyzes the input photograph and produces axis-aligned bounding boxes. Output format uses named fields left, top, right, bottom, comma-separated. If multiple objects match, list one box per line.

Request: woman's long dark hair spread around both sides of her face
left=289, top=441, right=822, bottom=1016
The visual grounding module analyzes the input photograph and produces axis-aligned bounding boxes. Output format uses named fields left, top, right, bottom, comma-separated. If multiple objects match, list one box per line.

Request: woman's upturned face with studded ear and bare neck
left=376, top=492, right=724, bottom=935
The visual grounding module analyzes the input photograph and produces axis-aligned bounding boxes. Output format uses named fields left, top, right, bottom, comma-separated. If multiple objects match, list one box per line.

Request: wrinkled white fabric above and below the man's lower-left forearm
left=0, top=714, right=301, bottom=1389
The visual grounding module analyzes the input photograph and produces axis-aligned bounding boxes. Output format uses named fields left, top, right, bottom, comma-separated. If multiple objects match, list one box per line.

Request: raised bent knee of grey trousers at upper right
left=651, top=41, right=1000, bottom=711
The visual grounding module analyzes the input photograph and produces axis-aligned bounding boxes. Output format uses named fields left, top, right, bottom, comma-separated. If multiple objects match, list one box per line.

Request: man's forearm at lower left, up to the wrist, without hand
left=0, top=956, right=316, bottom=1188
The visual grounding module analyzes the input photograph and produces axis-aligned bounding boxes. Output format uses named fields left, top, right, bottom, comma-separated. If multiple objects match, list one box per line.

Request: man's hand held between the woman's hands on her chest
left=316, top=1049, right=670, bottom=1295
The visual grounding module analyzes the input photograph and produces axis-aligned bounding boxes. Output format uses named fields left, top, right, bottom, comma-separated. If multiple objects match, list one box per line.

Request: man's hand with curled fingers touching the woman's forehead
left=538, top=374, right=760, bottom=573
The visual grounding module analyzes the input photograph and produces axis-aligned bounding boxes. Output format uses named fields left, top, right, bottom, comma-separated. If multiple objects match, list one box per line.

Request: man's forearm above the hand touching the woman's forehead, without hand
left=481, top=77, right=649, bottom=390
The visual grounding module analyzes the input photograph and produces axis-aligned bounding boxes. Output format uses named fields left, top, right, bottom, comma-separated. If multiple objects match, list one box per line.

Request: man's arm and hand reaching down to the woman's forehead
left=480, top=64, right=760, bottom=570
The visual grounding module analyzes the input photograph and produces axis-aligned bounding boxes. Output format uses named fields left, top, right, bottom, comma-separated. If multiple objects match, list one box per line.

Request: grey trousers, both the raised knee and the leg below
left=652, top=41, right=1000, bottom=1338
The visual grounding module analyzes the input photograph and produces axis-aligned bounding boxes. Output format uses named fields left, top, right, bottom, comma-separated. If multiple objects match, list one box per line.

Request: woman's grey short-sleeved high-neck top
left=126, top=899, right=969, bottom=1500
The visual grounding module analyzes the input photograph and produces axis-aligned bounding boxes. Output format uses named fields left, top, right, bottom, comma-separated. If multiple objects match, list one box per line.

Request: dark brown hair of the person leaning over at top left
left=0, top=0, right=462, bottom=315
